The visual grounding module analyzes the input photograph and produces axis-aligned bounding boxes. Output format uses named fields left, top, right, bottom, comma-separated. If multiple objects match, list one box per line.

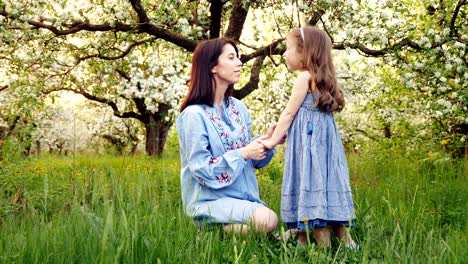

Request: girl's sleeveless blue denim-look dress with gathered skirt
left=281, top=93, right=355, bottom=229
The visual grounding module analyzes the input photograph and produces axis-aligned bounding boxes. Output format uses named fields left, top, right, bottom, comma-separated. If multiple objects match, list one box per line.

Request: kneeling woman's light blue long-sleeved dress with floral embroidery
left=176, top=97, right=274, bottom=223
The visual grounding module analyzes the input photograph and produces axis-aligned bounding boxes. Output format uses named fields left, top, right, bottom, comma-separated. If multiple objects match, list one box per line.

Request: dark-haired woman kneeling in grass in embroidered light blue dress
left=176, top=38, right=278, bottom=234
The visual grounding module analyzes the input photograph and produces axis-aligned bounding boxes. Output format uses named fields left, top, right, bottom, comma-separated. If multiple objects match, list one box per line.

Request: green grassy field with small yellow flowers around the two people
left=0, top=150, right=468, bottom=263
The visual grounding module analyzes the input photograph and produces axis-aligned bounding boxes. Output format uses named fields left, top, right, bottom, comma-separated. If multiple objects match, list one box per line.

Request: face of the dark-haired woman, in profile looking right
left=211, top=44, right=242, bottom=85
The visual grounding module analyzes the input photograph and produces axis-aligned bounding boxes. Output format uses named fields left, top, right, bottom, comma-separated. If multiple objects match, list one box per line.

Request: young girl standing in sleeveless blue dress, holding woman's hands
left=261, top=27, right=357, bottom=249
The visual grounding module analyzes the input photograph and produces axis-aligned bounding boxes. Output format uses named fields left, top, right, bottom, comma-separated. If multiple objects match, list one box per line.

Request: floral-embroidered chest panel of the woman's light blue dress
left=203, top=98, right=249, bottom=151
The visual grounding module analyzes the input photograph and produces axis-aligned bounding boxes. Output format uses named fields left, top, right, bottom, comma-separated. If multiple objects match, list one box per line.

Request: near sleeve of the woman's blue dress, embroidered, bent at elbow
left=177, top=108, right=246, bottom=189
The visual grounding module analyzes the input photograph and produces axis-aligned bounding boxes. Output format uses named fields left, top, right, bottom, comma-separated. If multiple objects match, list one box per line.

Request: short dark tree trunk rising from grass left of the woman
left=145, top=115, right=171, bottom=156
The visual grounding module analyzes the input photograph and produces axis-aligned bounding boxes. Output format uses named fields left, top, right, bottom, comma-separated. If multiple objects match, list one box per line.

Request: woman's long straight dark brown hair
left=180, top=38, right=239, bottom=112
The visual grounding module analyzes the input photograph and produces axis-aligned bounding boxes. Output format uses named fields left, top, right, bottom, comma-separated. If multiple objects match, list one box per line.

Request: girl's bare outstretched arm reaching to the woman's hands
left=262, top=71, right=310, bottom=149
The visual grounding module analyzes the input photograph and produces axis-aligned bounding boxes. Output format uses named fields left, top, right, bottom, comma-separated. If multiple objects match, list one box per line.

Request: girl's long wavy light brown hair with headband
left=287, top=27, right=344, bottom=112
